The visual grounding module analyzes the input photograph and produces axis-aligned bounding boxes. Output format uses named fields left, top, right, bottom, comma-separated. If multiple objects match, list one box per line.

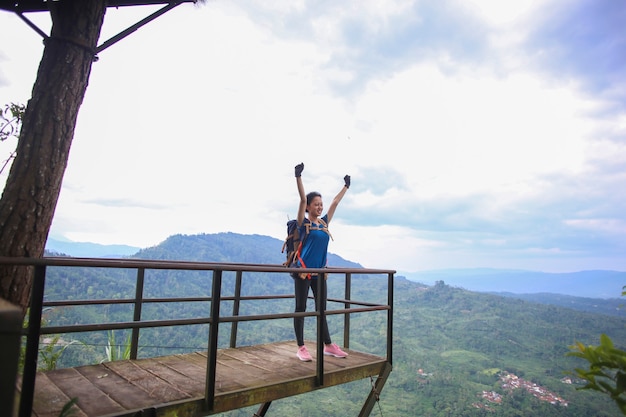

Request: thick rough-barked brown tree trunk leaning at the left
left=0, top=0, right=106, bottom=312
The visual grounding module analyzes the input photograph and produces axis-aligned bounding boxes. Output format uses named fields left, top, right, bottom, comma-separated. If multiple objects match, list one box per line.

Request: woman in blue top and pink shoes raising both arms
left=292, top=163, right=350, bottom=362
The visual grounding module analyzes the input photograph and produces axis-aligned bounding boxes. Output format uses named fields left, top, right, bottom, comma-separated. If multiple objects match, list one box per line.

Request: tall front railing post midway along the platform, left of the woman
left=204, top=269, right=222, bottom=411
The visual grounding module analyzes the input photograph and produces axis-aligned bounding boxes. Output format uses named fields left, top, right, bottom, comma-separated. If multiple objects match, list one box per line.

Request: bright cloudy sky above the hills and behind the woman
left=0, top=0, right=626, bottom=272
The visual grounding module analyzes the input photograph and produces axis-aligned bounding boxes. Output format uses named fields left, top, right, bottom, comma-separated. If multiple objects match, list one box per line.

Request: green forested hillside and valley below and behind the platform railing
left=41, top=233, right=626, bottom=417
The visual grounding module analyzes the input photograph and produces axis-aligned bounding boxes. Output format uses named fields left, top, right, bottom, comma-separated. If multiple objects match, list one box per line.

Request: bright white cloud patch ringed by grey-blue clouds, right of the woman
left=354, top=65, right=592, bottom=195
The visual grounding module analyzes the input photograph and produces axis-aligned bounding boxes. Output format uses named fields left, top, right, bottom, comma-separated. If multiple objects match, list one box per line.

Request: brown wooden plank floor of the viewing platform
left=24, top=341, right=386, bottom=417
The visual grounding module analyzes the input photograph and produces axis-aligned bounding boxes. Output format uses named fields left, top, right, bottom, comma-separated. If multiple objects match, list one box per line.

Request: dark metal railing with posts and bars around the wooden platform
left=0, top=257, right=395, bottom=417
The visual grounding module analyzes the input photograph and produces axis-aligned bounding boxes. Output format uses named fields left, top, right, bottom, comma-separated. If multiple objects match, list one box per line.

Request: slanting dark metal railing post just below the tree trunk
left=19, top=265, right=46, bottom=417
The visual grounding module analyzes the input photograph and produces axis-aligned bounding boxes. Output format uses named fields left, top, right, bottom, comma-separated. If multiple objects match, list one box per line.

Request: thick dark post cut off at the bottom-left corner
left=0, top=298, right=24, bottom=416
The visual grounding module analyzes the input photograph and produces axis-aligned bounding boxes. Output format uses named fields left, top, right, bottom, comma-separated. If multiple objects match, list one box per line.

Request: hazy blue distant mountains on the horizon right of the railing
left=399, top=268, right=626, bottom=298
